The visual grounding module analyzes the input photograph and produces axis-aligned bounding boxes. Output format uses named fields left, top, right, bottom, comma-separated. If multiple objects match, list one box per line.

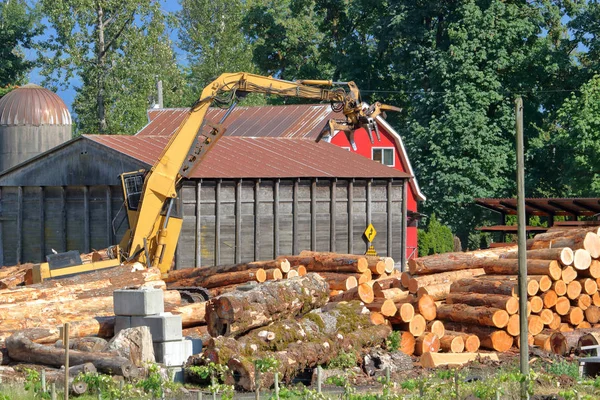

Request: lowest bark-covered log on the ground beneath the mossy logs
left=227, top=325, right=391, bottom=391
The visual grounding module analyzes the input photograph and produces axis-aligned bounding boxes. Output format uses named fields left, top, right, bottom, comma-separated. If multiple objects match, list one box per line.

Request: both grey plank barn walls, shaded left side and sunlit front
left=0, top=179, right=405, bottom=268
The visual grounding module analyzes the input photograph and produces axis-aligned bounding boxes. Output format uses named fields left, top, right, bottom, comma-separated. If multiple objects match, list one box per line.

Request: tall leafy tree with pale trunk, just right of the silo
left=40, top=0, right=186, bottom=133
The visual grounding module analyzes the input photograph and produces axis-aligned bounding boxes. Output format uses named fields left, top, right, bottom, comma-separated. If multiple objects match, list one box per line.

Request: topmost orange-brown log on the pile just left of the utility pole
left=408, top=246, right=516, bottom=275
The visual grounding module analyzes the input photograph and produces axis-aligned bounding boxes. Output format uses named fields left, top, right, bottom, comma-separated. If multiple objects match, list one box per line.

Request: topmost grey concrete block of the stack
left=113, top=288, right=165, bottom=316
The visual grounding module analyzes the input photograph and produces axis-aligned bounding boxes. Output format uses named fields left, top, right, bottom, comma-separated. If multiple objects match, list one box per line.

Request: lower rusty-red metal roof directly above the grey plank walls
left=84, top=135, right=411, bottom=179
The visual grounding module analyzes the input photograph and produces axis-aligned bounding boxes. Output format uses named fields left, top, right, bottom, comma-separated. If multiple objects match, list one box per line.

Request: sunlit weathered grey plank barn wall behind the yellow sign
left=176, top=179, right=405, bottom=268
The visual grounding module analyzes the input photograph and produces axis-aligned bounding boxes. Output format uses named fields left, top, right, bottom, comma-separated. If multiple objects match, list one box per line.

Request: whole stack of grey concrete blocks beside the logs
left=113, top=288, right=194, bottom=367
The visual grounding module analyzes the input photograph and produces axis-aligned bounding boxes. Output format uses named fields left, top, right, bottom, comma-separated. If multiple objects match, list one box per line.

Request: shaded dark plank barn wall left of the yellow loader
left=0, top=186, right=127, bottom=265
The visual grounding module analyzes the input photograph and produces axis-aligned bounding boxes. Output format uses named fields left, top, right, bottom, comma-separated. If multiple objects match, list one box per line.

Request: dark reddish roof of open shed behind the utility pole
left=475, top=197, right=600, bottom=216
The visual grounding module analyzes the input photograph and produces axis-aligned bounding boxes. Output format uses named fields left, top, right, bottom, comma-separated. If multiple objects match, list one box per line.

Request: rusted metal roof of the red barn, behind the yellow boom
left=136, top=104, right=344, bottom=139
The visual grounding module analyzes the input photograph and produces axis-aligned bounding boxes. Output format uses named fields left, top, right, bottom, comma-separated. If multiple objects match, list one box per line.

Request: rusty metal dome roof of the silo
left=0, top=83, right=71, bottom=126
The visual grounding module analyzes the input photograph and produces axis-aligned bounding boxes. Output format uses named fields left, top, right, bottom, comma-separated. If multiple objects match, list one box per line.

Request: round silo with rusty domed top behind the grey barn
left=0, top=84, right=71, bottom=171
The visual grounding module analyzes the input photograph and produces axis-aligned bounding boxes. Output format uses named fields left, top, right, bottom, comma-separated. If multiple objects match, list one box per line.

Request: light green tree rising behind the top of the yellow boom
left=178, top=0, right=255, bottom=93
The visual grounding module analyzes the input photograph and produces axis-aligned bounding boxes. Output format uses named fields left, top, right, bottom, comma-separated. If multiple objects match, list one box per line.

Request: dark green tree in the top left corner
left=0, top=0, right=41, bottom=86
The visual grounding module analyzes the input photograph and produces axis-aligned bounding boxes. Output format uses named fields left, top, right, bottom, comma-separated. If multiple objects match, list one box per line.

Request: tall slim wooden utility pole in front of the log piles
left=515, top=97, right=529, bottom=399
